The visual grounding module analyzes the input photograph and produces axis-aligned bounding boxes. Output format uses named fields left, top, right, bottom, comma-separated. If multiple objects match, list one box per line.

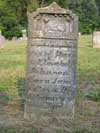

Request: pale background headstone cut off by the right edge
left=93, top=31, right=100, bottom=48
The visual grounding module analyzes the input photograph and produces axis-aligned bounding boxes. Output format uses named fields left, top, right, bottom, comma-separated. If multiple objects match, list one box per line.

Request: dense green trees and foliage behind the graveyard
left=0, top=0, right=100, bottom=39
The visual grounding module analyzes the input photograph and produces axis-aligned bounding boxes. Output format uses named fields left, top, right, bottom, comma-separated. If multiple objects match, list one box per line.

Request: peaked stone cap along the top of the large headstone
left=28, top=2, right=77, bottom=19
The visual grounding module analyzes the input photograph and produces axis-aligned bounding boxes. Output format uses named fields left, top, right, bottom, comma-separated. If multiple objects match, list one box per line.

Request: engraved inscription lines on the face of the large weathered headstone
left=27, top=40, right=76, bottom=110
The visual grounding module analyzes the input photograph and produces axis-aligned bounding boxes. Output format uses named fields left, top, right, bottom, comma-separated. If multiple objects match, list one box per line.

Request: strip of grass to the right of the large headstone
left=76, top=35, right=100, bottom=133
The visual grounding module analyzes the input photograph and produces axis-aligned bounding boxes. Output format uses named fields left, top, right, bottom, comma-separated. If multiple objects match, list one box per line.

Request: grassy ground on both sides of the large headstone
left=0, top=35, right=100, bottom=133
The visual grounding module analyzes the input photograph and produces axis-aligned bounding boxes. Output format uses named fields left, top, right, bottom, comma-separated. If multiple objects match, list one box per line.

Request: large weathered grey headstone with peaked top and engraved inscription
left=24, top=2, right=78, bottom=133
